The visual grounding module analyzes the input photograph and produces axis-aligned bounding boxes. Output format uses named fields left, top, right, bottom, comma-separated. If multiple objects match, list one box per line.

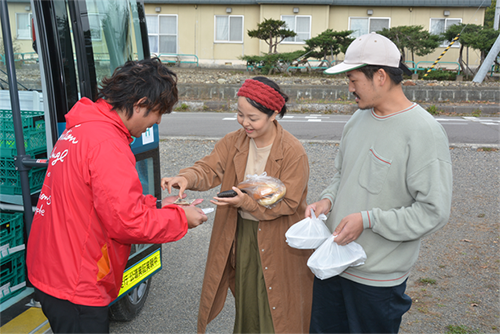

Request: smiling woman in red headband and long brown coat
left=162, top=77, right=313, bottom=334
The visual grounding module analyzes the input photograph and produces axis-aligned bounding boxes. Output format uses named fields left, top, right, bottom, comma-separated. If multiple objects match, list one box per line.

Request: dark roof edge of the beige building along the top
left=144, top=0, right=491, bottom=7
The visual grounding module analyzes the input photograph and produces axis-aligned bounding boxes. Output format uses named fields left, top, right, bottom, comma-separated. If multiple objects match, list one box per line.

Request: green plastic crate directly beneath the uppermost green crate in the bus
left=0, top=157, right=47, bottom=195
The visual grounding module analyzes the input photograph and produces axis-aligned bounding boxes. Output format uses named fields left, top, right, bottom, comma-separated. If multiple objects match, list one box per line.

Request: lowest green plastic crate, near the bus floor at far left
left=0, top=250, right=26, bottom=304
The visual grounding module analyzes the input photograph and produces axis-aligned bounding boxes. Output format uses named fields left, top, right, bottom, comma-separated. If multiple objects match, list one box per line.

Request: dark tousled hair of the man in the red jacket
left=97, top=58, right=178, bottom=119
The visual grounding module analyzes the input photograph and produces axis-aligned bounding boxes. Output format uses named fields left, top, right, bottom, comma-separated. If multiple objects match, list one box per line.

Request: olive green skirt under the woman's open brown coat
left=233, top=215, right=274, bottom=334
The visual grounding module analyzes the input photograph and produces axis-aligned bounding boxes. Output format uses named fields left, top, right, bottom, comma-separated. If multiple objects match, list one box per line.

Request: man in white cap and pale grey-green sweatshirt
left=306, top=33, right=452, bottom=334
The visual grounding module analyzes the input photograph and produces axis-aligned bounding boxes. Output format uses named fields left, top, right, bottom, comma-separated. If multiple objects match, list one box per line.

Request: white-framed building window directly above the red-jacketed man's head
left=146, top=15, right=178, bottom=54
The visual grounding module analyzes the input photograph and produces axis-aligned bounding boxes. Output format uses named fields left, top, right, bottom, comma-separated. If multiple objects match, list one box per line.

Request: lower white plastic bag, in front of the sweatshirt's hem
left=307, top=235, right=366, bottom=280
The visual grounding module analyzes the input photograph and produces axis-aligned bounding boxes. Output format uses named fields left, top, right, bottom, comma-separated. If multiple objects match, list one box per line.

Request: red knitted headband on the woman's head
left=238, top=79, right=285, bottom=112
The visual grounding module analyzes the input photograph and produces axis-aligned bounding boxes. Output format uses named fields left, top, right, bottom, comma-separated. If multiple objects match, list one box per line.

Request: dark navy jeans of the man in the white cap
left=310, top=276, right=411, bottom=334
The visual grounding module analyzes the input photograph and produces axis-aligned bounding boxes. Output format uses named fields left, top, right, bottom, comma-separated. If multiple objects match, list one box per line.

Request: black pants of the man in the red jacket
left=35, top=288, right=109, bottom=334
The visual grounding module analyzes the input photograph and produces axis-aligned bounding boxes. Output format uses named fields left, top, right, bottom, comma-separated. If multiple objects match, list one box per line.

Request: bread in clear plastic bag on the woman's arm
left=237, top=172, right=286, bottom=209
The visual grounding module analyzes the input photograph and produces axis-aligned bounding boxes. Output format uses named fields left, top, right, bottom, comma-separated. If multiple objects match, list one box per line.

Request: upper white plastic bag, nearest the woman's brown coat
left=285, top=209, right=332, bottom=249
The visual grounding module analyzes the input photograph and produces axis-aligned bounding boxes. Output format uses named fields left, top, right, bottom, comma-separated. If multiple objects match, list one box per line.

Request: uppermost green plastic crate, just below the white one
left=0, top=109, right=47, bottom=157
